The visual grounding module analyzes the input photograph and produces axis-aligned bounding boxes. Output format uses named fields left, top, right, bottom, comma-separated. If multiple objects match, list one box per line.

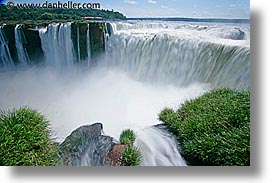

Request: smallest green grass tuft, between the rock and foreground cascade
left=119, top=129, right=141, bottom=166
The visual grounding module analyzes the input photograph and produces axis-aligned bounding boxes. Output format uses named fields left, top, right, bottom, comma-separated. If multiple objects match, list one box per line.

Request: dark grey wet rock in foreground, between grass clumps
left=59, top=123, right=115, bottom=166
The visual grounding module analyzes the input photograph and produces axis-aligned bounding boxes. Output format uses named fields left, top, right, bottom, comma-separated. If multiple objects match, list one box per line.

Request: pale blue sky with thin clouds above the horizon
left=4, top=0, right=250, bottom=19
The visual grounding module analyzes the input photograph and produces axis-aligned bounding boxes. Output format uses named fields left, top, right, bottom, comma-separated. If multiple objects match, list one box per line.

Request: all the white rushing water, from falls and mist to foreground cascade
left=0, top=21, right=250, bottom=166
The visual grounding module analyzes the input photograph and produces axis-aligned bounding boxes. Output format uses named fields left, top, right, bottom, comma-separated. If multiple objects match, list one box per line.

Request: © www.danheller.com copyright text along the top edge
left=6, top=1, right=100, bottom=9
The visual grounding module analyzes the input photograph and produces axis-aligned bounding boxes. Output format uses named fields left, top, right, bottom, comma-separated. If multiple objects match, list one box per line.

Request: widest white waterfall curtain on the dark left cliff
left=39, top=23, right=74, bottom=68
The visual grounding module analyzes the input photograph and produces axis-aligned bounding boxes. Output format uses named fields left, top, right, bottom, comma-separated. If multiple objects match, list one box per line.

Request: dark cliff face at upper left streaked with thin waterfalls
left=0, top=22, right=105, bottom=67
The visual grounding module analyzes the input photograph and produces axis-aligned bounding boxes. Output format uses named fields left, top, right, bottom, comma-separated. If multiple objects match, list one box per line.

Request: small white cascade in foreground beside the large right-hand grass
left=135, top=127, right=186, bottom=166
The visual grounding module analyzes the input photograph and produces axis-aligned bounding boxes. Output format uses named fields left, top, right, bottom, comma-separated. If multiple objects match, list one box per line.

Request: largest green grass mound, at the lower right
left=159, top=89, right=250, bottom=166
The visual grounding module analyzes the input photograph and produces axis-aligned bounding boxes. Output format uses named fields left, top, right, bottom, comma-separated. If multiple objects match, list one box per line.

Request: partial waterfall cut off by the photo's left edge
left=0, top=26, right=14, bottom=68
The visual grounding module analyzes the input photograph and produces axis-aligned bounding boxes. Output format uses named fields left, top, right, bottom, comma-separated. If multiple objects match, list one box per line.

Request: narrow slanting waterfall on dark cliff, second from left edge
left=14, top=24, right=30, bottom=65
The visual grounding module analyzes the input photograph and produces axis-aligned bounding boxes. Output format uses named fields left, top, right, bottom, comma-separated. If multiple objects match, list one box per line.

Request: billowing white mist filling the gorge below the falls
left=0, top=67, right=209, bottom=142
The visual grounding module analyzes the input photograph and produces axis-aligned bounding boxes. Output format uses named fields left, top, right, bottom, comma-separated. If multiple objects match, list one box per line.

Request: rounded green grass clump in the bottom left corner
left=0, top=107, right=57, bottom=166
